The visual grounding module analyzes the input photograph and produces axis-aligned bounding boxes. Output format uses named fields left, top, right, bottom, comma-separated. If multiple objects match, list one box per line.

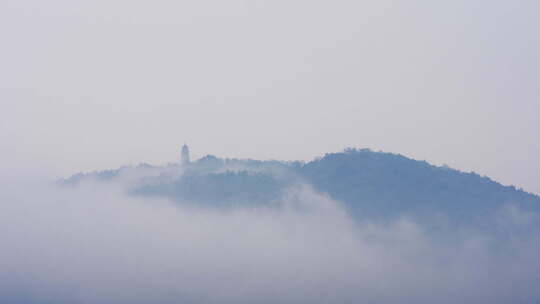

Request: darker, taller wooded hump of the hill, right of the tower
left=297, top=149, right=540, bottom=219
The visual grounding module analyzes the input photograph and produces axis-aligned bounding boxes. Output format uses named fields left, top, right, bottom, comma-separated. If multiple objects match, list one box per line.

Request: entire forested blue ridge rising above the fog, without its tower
left=65, top=149, right=540, bottom=221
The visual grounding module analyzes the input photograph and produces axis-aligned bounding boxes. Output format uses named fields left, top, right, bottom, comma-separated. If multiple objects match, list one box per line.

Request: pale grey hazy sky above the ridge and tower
left=0, top=0, right=540, bottom=193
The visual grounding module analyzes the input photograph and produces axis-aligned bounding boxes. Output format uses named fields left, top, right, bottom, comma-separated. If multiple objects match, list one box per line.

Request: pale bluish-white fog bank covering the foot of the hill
left=0, top=178, right=540, bottom=303
